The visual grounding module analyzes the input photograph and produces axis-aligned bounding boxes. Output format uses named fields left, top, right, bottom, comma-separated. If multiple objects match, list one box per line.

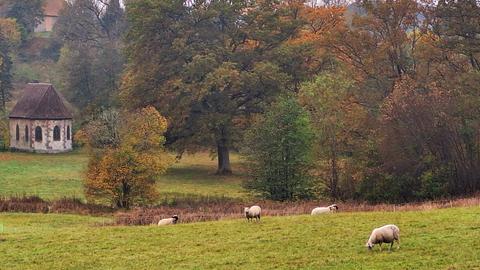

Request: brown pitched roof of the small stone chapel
left=9, top=83, right=72, bottom=120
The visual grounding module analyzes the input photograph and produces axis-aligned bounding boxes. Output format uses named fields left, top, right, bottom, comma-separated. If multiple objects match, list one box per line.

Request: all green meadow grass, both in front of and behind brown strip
left=0, top=152, right=480, bottom=270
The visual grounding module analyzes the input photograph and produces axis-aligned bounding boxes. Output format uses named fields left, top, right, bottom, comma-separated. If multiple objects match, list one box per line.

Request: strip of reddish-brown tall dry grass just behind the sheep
left=115, top=196, right=480, bottom=225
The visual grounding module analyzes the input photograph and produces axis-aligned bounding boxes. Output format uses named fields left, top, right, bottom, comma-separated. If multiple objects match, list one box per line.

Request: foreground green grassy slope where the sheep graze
left=0, top=207, right=480, bottom=269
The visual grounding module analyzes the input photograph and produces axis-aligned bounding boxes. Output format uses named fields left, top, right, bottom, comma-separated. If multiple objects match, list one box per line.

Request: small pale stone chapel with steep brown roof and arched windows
left=9, top=83, right=72, bottom=153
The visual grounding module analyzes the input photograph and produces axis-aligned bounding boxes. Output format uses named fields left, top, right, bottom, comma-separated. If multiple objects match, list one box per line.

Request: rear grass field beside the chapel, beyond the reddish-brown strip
left=0, top=152, right=246, bottom=199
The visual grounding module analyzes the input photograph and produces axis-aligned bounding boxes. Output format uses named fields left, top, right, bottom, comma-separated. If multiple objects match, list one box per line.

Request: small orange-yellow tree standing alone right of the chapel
left=85, top=107, right=172, bottom=209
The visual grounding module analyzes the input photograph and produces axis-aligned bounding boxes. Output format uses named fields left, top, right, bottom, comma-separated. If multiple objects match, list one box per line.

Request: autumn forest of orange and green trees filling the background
left=0, top=0, right=480, bottom=206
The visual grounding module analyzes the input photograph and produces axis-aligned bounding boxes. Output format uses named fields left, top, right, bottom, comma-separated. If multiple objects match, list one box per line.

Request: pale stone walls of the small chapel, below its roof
left=10, top=119, right=72, bottom=153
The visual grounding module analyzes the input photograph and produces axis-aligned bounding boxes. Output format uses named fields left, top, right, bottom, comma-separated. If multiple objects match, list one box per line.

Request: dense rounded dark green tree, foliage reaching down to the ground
left=245, top=97, right=313, bottom=201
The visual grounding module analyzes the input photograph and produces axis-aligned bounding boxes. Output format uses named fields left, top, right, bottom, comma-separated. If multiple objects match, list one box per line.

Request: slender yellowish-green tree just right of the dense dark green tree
left=299, top=71, right=369, bottom=199
